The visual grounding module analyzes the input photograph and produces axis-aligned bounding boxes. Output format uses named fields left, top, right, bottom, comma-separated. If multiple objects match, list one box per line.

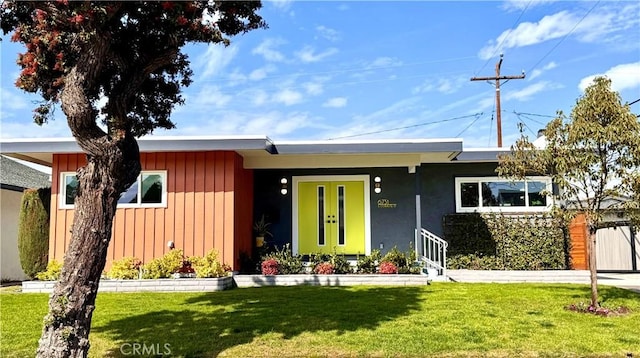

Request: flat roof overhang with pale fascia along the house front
left=0, top=136, right=484, bottom=169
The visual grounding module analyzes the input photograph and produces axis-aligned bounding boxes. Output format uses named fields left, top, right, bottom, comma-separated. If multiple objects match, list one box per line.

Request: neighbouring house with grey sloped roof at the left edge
left=0, top=156, right=51, bottom=281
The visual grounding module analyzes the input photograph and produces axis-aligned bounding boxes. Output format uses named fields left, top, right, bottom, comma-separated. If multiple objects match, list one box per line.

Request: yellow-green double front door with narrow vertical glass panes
left=297, top=181, right=367, bottom=255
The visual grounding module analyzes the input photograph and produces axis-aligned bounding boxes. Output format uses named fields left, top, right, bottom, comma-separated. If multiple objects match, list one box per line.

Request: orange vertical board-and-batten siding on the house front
left=49, top=151, right=253, bottom=270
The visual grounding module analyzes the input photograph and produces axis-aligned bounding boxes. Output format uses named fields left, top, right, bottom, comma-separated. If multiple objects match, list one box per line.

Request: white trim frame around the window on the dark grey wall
left=455, top=176, right=553, bottom=213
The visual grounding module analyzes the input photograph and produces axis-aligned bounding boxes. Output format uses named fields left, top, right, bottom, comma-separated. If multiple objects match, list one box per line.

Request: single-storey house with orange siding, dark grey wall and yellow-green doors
left=0, top=137, right=551, bottom=270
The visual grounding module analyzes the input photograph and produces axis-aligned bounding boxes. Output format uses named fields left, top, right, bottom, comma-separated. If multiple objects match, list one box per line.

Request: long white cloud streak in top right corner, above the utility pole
left=478, top=3, right=640, bottom=60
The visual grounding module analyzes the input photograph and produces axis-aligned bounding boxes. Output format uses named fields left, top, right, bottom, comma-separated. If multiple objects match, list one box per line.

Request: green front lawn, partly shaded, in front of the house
left=0, top=283, right=640, bottom=357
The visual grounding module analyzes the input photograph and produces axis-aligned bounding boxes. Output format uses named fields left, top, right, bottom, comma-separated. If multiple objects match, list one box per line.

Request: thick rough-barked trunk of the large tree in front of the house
left=37, top=135, right=140, bottom=358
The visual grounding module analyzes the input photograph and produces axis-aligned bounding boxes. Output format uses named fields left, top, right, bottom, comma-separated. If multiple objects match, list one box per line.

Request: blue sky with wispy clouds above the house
left=0, top=0, right=640, bottom=148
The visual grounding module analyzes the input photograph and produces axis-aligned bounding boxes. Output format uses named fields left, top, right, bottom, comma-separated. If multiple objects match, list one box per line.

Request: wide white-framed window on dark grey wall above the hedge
left=455, top=177, right=551, bottom=212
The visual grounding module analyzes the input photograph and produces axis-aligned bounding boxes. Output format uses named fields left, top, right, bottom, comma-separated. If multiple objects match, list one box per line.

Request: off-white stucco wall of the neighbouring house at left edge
left=0, top=189, right=27, bottom=281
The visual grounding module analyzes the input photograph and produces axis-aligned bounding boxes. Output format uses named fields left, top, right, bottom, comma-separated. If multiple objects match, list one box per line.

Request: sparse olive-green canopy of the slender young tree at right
left=497, top=77, right=640, bottom=226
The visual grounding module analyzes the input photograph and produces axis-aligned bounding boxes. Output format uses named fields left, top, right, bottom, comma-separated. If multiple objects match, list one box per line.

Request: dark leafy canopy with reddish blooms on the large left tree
left=0, top=0, right=266, bottom=136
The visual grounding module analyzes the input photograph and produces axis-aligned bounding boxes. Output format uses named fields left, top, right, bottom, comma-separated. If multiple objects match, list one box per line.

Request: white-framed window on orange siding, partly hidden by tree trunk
left=60, top=171, right=167, bottom=209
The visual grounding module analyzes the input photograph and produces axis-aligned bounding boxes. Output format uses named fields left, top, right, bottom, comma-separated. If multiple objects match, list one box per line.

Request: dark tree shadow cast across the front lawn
left=92, top=286, right=425, bottom=357
